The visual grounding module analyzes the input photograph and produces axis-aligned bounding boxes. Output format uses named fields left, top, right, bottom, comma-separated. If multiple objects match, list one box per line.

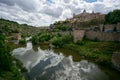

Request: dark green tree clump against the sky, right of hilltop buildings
left=105, top=10, right=120, bottom=24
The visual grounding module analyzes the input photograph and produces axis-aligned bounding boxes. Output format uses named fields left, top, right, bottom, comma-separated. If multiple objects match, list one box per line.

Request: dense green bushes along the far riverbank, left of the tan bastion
left=31, top=31, right=72, bottom=47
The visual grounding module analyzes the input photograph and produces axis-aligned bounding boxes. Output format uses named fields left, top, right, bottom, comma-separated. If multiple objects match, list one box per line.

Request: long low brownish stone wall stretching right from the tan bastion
left=85, top=31, right=120, bottom=41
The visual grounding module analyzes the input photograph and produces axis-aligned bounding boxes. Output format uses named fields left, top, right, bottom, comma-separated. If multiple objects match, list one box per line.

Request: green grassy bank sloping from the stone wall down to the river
left=64, top=41, right=120, bottom=65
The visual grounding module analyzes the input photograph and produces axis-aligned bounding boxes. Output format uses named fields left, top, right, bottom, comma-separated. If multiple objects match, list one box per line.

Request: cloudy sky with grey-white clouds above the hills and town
left=0, top=0, right=120, bottom=27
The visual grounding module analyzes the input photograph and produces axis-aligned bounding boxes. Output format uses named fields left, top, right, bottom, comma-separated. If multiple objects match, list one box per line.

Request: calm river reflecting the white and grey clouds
left=13, top=42, right=120, bottom=80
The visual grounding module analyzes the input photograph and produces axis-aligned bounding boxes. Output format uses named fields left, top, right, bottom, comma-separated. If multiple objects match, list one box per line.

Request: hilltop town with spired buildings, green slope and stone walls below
left=50, top=10, right=120, bottom=42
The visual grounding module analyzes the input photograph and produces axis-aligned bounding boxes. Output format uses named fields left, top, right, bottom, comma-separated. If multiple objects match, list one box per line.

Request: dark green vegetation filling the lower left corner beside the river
left=0, top=34, right=24, bottom=80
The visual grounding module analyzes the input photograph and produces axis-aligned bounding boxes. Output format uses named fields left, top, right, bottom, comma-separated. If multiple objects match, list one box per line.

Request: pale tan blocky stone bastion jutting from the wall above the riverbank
left=73, top=30, right=85, bottom=42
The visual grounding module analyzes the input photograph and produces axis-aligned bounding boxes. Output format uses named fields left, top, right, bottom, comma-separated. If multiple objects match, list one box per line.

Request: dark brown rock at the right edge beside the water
left=112, top=52, right=120, bottom=71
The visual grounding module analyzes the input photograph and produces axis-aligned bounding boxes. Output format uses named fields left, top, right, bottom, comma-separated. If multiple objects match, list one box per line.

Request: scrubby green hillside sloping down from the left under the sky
left=0, top=19, right=40, bottom=37
